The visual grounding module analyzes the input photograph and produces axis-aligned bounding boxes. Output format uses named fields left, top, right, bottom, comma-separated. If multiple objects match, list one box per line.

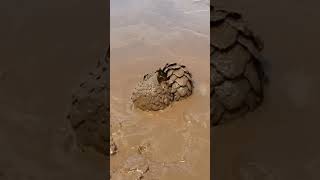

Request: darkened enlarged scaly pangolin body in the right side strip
left=210, top=6, right=265, bottom=126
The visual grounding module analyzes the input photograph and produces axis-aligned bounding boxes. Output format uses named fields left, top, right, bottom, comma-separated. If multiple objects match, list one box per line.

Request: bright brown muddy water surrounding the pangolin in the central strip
left=110, top=0, right=210, bottom=180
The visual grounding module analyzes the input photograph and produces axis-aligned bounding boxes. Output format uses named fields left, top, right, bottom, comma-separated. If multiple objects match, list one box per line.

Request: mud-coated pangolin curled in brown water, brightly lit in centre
left=131, top=63, right=193, bottom=111
